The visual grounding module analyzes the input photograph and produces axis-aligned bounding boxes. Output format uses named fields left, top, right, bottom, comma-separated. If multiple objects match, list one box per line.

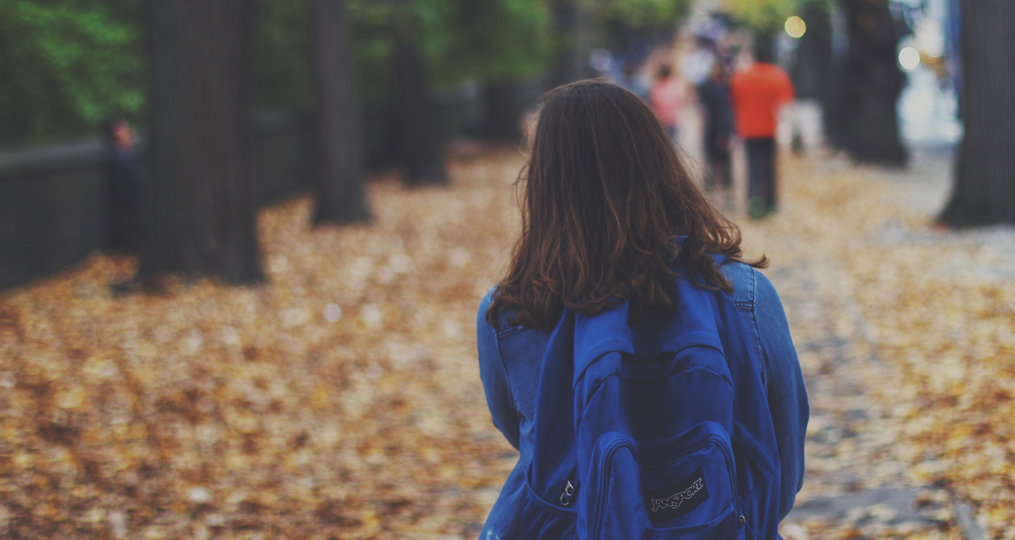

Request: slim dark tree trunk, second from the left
left=310, top=0, right=369, bottom=224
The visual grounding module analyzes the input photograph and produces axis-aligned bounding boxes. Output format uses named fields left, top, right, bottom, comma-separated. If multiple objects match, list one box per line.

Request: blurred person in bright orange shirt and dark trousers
left=730, top=40, right=794, bottom=217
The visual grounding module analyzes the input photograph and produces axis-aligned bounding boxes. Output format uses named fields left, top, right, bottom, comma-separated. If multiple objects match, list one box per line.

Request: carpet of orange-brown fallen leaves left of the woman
left=0, top=151, right=522, bottom=539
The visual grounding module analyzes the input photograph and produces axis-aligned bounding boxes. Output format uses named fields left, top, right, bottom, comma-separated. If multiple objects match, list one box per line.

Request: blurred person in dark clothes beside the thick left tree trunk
left=102, top=118, right=146, bottom=253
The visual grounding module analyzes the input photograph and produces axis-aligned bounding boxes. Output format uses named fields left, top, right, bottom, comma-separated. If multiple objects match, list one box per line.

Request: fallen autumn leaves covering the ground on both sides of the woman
left=0, top=145, right=1015, bottom=539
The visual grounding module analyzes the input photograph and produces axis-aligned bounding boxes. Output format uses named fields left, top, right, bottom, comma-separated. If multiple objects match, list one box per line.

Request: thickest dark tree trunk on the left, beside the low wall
left=140, top=0, right=263, bottom=282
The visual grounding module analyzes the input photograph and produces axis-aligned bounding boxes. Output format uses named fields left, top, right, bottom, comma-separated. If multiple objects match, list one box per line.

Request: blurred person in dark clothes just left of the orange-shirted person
left=697, top=62, right=734, bottom=205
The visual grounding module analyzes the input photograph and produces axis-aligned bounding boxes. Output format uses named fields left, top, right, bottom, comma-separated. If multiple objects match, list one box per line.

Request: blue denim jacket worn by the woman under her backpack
left=476, top=262, right=810, bottom=540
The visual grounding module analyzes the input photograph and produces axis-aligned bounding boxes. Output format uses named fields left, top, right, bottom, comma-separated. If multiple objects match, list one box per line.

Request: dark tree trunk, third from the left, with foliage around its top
left=394, top=30, right=448, bottom=186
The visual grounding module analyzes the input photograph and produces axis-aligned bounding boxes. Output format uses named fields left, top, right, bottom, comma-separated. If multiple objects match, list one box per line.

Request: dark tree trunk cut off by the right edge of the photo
left=941, top=0, right=1015, bottom=226
